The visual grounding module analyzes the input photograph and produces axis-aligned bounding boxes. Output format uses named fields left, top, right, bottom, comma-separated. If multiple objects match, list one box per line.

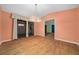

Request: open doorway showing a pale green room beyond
left=45, top=19, right=55, bottom=37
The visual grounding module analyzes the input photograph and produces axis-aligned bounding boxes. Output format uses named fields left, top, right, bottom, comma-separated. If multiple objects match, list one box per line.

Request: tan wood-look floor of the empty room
left=0, top=35, right=79, bottom=55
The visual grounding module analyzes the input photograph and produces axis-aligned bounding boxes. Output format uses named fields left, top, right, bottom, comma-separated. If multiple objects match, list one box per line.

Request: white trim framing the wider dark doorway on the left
left=12, top=14, right=28, bottom=39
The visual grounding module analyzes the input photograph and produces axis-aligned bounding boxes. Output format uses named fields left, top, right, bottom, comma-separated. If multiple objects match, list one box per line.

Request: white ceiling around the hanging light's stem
left=1, top=4, right=79, bottom=17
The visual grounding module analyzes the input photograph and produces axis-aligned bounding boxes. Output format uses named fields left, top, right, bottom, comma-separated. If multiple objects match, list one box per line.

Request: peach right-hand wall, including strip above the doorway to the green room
left=39, top=8, right=79, bottom=43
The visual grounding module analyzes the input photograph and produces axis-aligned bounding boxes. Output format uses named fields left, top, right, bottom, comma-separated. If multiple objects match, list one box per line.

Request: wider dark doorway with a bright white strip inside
left=17, top=20, right=26, bottom=38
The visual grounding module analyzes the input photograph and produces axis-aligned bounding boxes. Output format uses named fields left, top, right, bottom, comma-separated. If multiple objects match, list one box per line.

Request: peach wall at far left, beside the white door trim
left=0, top=11, right=12, bottom=42
